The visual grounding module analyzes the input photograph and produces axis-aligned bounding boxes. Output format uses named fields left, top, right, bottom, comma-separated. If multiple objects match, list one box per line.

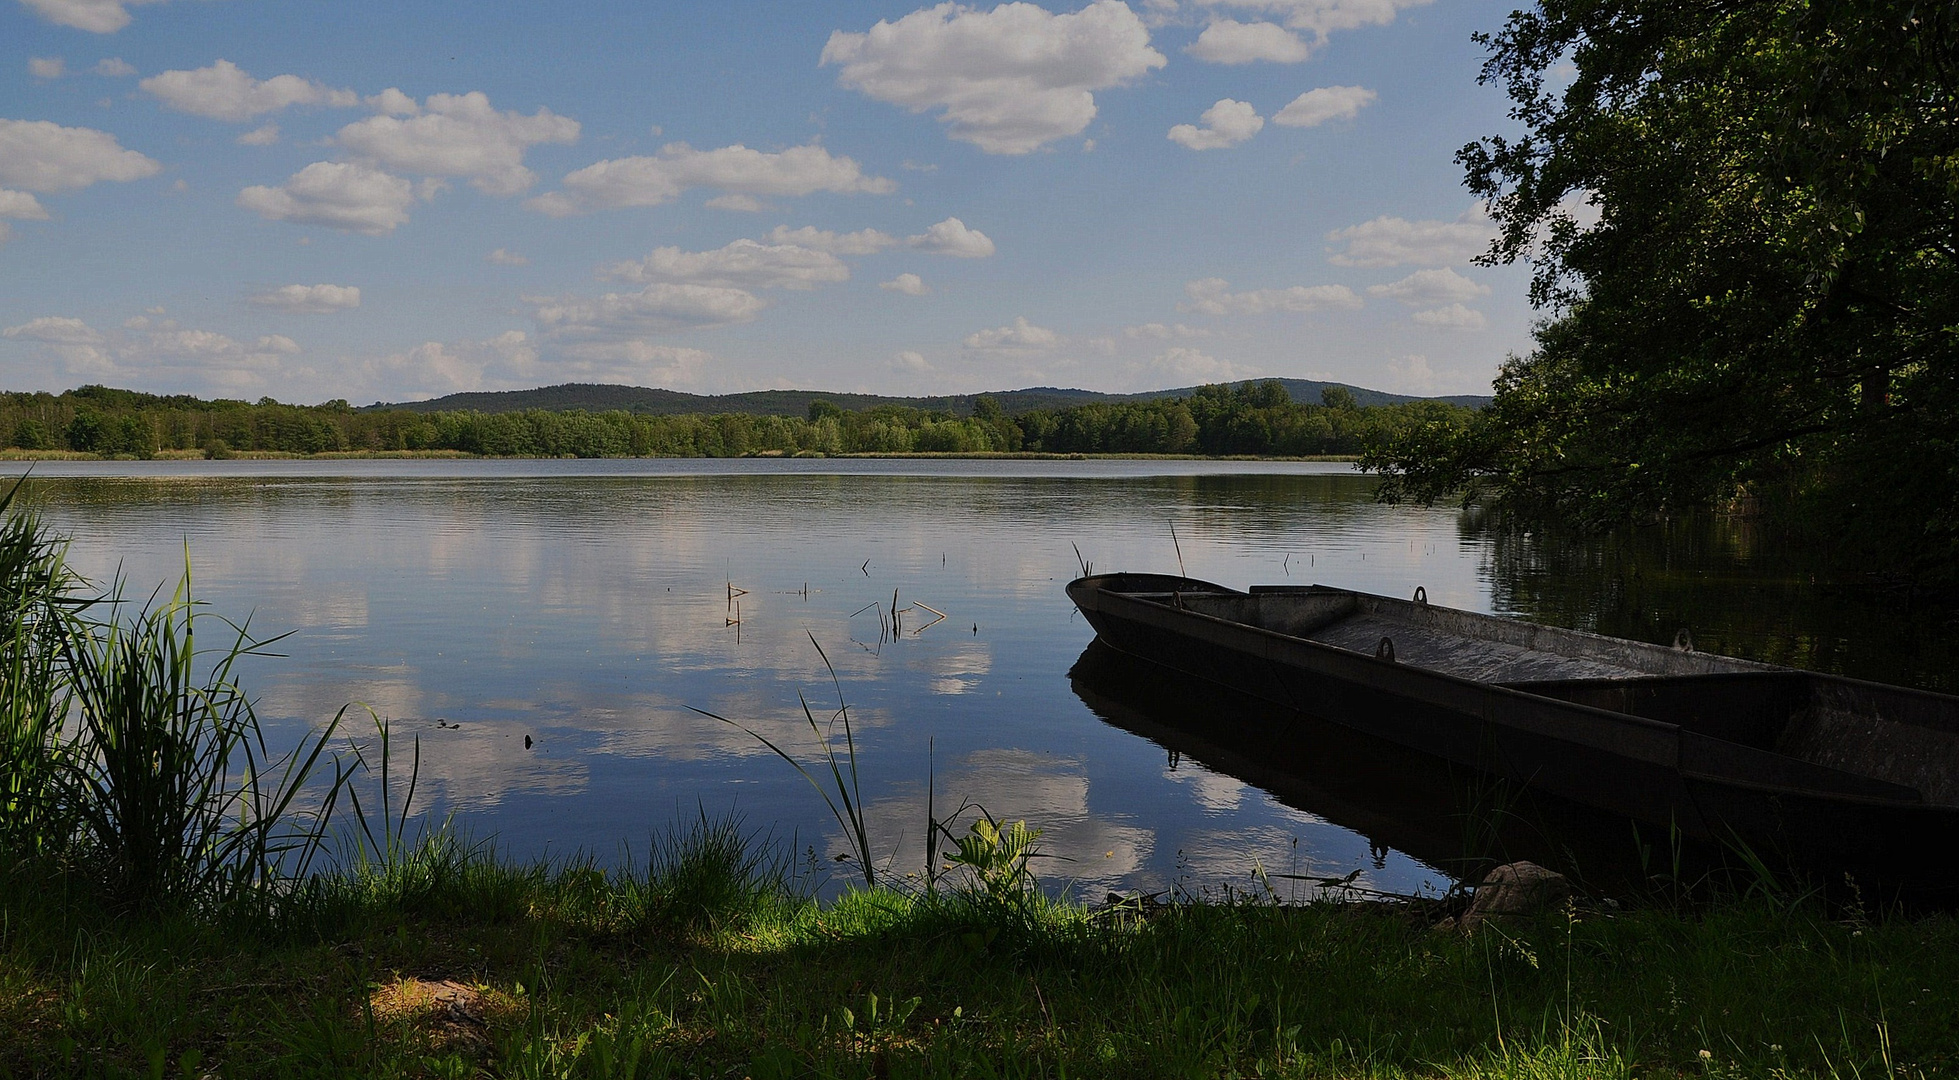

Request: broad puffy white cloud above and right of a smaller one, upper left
left=335, top=90, right=578, bottom=196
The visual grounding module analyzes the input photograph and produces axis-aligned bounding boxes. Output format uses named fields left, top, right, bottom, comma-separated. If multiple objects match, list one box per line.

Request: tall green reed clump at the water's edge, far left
left=0, top=484, right=349, bottom=911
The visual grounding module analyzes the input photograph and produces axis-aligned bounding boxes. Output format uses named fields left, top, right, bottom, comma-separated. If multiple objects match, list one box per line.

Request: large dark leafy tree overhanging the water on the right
left=1363, top=0, right=1959, bottom=572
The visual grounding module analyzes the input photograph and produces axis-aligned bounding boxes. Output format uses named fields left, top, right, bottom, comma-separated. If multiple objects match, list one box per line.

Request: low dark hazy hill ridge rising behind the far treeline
left=368, top=378, right=1489, bottom=416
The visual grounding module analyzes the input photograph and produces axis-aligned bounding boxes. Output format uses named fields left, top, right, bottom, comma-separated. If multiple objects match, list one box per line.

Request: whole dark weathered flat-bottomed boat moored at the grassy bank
left=1068, top=574, right=1959, bottom=888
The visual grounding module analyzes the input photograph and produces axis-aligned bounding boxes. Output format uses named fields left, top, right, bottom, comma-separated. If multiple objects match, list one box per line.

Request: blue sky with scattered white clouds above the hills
left=0, top=0, right=1534, bottom=402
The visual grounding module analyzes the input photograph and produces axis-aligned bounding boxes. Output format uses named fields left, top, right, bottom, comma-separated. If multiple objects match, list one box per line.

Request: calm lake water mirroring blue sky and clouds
left=11, top=459, right=1953, bottom=898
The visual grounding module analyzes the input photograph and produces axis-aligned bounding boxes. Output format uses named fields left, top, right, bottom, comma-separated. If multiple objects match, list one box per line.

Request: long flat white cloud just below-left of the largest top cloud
left=525, top=143, right=897, bottom=218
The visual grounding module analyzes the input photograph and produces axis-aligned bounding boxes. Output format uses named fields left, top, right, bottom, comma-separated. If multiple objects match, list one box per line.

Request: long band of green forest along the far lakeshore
left=0, top=380, right=1473, bottom=459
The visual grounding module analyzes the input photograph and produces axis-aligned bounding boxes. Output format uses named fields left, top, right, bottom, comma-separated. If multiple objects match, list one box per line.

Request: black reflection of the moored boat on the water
left=1068, top=639, right=1692, bottom=896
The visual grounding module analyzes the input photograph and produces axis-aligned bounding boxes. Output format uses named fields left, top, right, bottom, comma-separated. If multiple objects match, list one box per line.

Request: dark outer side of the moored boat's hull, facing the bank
left=1068, top=574, right=1959, bottom=886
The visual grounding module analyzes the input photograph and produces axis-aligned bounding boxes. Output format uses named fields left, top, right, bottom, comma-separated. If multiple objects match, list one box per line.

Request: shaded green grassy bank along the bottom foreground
left=0, top=827, right=1959, bottom=1080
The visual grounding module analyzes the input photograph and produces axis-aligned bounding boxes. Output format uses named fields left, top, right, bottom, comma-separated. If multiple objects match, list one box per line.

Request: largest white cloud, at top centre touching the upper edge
left=821, top=0, right=1168, bottom=153
